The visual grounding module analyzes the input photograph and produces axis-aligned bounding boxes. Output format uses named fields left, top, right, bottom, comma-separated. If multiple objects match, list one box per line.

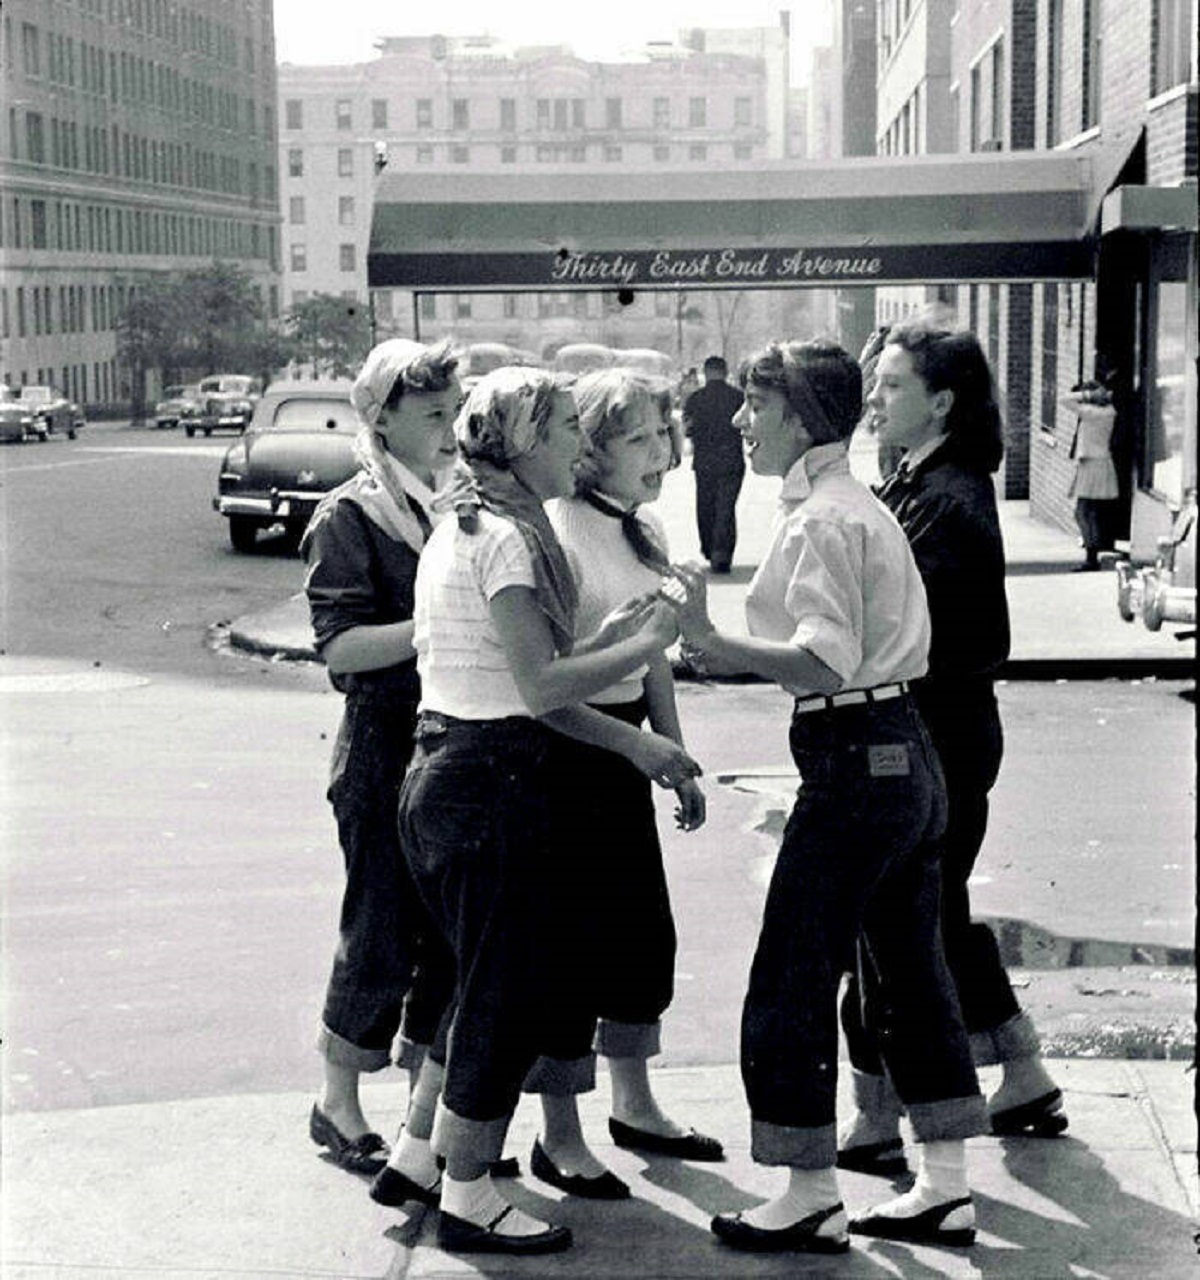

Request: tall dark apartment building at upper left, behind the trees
left=0, top=0, right=279, bottom=412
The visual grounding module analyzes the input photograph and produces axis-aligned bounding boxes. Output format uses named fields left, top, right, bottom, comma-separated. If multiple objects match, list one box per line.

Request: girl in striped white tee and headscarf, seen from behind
left=400, top=369, right=699, bottom=1253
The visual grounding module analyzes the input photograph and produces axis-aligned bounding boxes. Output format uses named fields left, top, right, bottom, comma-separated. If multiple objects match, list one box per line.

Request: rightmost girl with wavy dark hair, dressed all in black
left=838, top=323, right=1067, bottom=1176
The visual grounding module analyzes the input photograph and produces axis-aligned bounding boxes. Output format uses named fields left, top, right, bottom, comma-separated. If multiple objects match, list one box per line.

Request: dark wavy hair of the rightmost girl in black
left=888, top=321, right=1004, bottom=474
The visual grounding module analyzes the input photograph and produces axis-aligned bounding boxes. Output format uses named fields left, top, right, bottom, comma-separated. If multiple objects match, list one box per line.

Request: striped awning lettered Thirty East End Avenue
left=367, top=151, right=1094, bottom=291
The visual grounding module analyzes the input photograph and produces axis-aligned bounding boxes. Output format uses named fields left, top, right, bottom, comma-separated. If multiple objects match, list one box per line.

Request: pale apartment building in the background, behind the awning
left=279, top=22, right=792, bottom=358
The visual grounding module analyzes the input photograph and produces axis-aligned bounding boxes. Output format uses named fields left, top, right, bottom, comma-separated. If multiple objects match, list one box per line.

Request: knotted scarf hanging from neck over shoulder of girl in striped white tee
left=435, top=457, right=580, bottom=654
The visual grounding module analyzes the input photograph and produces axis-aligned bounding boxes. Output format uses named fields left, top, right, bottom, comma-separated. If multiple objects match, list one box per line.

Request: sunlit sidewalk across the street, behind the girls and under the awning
left=230, top=470, right=1195, bottom=680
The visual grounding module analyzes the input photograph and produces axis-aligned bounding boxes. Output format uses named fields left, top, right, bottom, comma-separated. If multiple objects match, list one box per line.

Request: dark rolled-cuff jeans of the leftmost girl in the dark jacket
left=317, top=695, right=454, bottom=1071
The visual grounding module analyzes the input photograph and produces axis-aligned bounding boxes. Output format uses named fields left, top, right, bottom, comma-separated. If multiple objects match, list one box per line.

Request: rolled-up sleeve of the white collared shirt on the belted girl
left=786, top=520, right=864, bottom=681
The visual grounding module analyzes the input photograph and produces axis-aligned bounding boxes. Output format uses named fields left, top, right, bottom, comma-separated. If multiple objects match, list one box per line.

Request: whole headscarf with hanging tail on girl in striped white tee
left=436, top=367, right=578, bottom=653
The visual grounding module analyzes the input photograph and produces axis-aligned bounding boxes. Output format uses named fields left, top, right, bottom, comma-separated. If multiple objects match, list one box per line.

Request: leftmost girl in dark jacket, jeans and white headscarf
left=302, top=339, right=462, bottom=1174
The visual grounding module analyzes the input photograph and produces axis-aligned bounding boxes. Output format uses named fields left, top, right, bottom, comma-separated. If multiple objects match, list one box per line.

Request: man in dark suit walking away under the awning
left=683, top=356, right=746, bottom=573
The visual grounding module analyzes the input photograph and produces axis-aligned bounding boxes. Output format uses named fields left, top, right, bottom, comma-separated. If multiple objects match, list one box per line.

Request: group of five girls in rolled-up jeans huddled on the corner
left=294, top=325, right=1066, bottom=1253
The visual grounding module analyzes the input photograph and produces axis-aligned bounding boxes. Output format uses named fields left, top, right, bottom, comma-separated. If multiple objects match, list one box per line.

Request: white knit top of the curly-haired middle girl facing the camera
left=546, top=498, right=667, bottom=704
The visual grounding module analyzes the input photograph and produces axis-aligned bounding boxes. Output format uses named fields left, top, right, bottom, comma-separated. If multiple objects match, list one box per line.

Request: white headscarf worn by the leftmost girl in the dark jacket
left=347, top=338, right=447, bottom=554
